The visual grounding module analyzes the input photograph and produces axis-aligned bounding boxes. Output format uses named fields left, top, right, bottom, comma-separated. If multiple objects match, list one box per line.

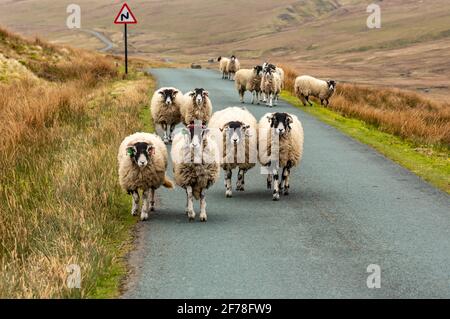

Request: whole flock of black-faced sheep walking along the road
left=118, top=56, right=335, bottom=222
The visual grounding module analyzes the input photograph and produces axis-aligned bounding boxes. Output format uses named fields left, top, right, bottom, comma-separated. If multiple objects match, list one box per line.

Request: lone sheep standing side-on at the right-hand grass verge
left=294, top=75, right=336, bottom=106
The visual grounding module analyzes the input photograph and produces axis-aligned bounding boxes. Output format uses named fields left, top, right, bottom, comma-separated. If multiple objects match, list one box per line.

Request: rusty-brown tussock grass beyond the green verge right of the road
left=283, top=66, right=450, bottom=148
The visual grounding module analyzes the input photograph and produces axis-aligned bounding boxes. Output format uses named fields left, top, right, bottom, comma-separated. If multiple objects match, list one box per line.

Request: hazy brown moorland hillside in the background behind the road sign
left=0, top=0, right=450, bottom=98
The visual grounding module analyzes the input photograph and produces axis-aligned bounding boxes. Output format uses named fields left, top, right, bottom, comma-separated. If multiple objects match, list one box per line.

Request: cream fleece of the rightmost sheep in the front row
left=258, top=113, right=304, bottom=167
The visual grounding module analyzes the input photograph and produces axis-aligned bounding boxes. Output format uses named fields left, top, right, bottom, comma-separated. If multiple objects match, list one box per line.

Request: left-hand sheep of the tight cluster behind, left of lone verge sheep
left=235, top=65, right=262, bottom=104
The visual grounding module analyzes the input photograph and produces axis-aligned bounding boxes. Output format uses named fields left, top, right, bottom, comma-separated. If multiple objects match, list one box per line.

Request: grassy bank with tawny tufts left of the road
left=0, top=30, right=152, bottom=298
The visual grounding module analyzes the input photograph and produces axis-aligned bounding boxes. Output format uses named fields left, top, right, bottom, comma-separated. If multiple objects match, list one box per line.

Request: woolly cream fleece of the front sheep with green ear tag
left=117, top=133, right=172, bottom=191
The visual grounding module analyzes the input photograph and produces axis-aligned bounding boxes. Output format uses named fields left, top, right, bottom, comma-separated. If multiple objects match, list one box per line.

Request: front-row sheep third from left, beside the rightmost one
left=209, top=107, right=258, bottom=197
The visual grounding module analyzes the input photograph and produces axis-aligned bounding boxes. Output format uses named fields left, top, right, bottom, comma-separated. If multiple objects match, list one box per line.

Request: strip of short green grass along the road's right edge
left=281, top=91, right=450, bottom=194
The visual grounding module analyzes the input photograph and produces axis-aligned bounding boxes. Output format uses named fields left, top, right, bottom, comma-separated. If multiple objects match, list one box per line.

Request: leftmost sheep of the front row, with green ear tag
left=117, top=133, right=173, bottom=221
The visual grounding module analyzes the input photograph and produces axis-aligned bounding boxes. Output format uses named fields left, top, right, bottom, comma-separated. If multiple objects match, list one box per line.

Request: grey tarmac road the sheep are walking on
left=123, top=69, right=450, bottom=298
